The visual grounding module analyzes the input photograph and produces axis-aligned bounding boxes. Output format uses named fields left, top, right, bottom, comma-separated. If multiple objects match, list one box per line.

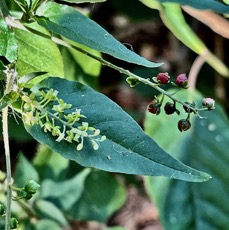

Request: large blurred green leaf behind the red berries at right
left=145, top=91, right=229, bottom=230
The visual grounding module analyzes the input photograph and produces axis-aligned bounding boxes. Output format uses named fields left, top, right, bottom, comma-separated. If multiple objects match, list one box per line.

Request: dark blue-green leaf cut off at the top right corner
left=157, top=0, right=229, bottom=13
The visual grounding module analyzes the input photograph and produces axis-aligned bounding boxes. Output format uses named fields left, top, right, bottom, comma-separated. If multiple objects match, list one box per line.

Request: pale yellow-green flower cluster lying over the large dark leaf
left=21, top=89, right=106, bottom=151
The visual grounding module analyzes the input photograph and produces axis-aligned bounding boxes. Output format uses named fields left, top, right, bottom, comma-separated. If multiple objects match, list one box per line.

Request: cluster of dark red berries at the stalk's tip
left=147, top=73, right=215, bottom=132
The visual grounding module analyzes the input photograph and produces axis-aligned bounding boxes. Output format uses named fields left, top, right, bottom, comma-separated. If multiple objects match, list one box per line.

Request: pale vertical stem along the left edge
left=2, top=106, right=12, bottom=230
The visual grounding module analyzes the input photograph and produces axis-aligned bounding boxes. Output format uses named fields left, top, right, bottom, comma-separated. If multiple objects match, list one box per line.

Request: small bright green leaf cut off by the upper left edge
left=0, top=19, right=18, bottom=62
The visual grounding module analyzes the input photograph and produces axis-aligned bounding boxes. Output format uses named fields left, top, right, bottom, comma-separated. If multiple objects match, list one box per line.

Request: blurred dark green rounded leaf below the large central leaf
left=68, top=171, right=126, bottom=222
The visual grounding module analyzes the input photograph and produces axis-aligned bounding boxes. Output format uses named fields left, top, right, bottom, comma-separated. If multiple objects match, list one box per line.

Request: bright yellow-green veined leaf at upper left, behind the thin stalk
left=15, top=24, right=64, bottom=79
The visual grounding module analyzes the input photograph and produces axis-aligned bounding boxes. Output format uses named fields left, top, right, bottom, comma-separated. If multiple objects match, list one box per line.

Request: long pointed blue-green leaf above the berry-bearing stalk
left=36, top=2, right=161, bottom=68
